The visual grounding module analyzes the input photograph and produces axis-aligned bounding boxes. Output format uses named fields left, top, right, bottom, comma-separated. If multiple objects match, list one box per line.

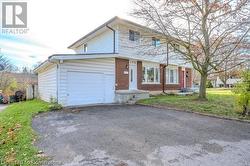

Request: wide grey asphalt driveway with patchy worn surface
left=33, top=105, right=250, bottom=166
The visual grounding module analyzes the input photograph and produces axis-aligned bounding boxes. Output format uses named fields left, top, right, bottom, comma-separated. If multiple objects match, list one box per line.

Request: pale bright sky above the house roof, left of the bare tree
left=0, top=0, right=135, bottom=67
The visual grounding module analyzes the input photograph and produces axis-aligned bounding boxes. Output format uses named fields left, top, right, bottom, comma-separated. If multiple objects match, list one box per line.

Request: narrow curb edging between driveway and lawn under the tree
left=136, top=103, right=250, bottom=124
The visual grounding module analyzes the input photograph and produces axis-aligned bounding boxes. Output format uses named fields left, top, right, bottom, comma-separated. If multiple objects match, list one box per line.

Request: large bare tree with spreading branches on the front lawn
left=133, top=0, right=250, bottom=100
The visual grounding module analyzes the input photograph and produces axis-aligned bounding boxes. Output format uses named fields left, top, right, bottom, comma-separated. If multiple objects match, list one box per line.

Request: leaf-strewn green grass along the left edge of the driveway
left=0, top=100, right=50, bottom=166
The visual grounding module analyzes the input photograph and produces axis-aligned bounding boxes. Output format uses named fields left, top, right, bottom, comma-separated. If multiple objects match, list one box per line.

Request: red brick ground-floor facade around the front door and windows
left=115, top=58, right=192, bottom=91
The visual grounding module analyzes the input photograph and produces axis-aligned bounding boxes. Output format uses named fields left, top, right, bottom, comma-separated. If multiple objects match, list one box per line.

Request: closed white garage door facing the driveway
left=67, top=72, right=114, bottom=105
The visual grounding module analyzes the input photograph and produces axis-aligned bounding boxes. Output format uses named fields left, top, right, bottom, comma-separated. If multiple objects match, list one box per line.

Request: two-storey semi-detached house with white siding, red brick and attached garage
left=35, top=17, right=193, bottom=106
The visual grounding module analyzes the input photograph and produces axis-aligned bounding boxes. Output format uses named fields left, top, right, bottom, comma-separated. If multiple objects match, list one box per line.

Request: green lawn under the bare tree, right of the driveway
left=138, top=89, right=250, bottom=119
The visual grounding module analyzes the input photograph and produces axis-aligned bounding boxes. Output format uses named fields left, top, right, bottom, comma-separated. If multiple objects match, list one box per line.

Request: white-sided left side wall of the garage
left=38, top=65, right=57, bottom=102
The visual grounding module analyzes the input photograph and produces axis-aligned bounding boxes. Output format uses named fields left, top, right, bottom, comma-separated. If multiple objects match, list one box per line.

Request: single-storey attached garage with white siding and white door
left=37, top=56, right=115, bottom=106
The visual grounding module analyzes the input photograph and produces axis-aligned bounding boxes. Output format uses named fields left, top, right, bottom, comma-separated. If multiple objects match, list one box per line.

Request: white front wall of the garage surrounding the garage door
left=59, top=58, right=115, bottom=106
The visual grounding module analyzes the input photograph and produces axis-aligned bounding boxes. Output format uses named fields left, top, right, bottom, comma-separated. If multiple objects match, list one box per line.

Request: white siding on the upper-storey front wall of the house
left=117, top=24, right=192, bottom=67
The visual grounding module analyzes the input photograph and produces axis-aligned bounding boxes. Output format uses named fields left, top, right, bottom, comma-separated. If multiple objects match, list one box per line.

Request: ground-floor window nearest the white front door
left=142, top=66, right=160, bottom=83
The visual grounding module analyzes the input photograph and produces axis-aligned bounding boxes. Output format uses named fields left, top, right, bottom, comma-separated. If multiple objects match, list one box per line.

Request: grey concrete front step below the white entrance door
left=115, top=90, right=149, bottom=104
